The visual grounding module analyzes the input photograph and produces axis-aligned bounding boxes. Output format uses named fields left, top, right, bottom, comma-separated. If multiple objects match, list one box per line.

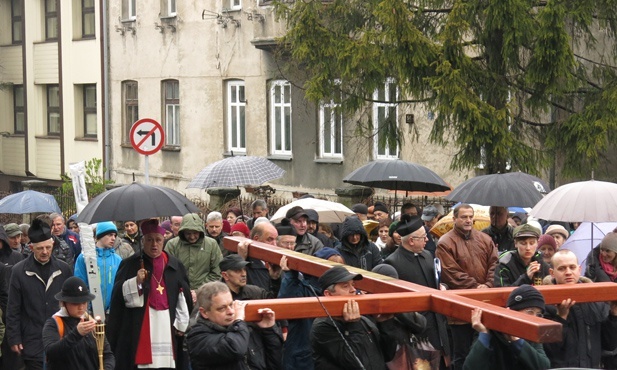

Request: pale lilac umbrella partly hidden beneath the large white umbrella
left=560, top=222, right=617, bottom=274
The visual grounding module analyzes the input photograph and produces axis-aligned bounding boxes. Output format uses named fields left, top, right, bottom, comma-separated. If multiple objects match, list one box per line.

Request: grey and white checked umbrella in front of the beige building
left=187, top=156, right=285, bottom=189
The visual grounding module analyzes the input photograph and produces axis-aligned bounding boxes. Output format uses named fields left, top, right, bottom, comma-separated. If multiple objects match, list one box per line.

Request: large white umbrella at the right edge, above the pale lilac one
left=530, top=180, right=617, bottom=222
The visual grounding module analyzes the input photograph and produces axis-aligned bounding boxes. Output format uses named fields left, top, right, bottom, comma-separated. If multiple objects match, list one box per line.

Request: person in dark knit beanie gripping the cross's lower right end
left=463, top=284, right=550, bottom=370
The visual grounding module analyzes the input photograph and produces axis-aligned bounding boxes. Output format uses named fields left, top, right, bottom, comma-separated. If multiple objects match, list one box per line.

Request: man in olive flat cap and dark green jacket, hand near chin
left=495, top=224, right=550, bottom=286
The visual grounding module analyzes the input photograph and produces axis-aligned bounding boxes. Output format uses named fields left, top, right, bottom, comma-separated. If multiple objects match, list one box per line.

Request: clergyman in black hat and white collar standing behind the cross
left=384, top=217, right=450, bottom=366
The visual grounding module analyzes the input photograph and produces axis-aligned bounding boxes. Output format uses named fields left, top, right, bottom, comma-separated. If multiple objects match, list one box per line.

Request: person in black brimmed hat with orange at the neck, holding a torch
left=43, top=276, right=115, bottom=370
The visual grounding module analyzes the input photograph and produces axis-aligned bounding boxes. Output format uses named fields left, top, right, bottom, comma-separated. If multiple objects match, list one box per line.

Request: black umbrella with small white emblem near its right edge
left=446, top=172, right=546, bottom=207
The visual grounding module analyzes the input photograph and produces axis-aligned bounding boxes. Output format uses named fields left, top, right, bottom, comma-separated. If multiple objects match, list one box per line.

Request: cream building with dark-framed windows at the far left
left=0, top=0, right=105, bottom=190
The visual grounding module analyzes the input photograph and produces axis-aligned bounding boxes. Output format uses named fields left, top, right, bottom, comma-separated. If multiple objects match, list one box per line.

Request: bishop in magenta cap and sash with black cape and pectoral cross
left=107, top=220, right=193, bottom=370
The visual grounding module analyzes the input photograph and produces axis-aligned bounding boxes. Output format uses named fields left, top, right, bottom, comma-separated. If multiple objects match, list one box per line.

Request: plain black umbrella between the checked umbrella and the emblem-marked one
left=343, top=159, right=451, bottom=192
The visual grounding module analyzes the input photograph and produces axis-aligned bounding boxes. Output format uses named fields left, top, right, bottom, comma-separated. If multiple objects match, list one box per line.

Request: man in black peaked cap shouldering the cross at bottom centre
left=311, top=266, right=396, bottom=369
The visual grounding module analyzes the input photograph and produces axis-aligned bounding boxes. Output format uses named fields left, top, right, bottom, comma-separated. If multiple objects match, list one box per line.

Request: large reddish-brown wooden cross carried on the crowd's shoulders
left=223, top=237, right=617, bottom=343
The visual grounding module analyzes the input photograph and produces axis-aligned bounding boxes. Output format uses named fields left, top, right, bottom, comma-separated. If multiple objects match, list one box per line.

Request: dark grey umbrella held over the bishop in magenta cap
left=77, top=182, right=201, bottom=224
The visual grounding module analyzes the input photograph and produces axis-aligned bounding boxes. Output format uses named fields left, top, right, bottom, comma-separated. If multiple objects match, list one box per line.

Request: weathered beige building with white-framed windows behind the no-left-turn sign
left=109, top=0, right=470, bottom=196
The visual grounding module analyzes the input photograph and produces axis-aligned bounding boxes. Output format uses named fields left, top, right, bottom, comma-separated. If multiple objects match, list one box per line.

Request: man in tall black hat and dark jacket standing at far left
left=6, top=219, right=73, bottom=370
